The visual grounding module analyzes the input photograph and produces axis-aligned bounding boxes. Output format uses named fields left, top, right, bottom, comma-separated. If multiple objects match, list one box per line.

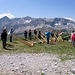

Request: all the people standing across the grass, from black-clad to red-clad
left=1, top=27, right=75, bottom=48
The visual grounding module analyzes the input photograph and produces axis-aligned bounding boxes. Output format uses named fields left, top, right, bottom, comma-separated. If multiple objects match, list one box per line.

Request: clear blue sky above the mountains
left=0, top=0, right=75, bottom=18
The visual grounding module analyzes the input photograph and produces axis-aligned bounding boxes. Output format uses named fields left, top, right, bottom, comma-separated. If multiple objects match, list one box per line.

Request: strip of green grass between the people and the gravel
left=0, top=40, right=75, bottom=61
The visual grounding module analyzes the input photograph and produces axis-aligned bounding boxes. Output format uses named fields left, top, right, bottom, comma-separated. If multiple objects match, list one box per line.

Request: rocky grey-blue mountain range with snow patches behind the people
left=0, top=16, right=75, bottom=33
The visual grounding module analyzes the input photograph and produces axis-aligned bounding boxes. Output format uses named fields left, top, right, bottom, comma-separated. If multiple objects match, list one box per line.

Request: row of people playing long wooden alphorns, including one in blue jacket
left=24, top=29, right=60, bottom=44
